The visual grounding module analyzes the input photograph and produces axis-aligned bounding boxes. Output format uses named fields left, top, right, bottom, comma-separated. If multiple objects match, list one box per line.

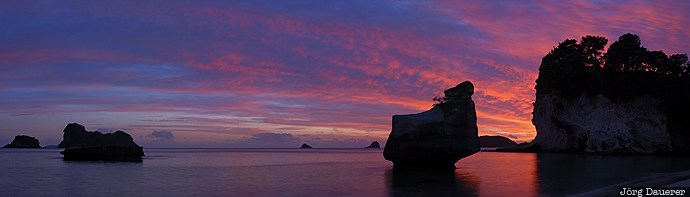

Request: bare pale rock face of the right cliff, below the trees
left=530, top=94, right=673, bottom=154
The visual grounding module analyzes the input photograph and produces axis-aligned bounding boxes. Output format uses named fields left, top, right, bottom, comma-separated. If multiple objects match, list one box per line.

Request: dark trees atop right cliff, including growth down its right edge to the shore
left=535, top=33, right=690, bottom=153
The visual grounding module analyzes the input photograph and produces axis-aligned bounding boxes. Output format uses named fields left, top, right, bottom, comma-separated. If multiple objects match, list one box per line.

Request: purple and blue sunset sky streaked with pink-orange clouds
left=0, top=0, right=690, bottom=148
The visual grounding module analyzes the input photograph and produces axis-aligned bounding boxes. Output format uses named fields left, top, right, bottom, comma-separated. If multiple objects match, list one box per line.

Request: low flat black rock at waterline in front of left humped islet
left=60, top=146, right=144, bottom=161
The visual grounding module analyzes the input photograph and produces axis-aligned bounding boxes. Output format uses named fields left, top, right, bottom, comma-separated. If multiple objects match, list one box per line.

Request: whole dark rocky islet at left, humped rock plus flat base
left=58, top=123, right=144, bottom=161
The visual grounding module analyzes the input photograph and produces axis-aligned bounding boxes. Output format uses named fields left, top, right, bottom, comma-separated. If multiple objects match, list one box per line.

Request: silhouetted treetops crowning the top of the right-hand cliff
left=535, top=33, right=690, bottom=99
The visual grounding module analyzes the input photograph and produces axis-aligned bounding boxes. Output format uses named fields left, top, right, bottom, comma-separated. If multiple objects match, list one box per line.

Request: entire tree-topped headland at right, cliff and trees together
left=508, top=34, right=690, bottom=154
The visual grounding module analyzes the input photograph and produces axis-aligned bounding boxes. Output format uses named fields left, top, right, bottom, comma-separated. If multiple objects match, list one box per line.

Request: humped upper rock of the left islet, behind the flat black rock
left=58, top=123, right=139, bottom=148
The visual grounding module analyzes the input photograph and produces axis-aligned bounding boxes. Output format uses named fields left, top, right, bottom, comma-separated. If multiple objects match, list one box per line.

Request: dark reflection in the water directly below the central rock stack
left=386, top=169, right=479, bottom=197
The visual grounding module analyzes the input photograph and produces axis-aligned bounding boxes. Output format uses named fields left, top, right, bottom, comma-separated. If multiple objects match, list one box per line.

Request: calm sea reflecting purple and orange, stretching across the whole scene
left=0, top=149, right=690, bottom=196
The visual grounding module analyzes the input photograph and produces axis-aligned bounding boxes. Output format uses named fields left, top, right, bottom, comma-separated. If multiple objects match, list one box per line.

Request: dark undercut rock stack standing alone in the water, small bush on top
left=383, top=81, right=479, bottom=170
